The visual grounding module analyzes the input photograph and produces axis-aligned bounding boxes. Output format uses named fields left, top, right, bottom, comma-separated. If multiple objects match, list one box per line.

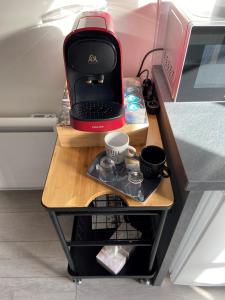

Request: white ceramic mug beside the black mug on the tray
left=104, top=131, right=136, bottom=164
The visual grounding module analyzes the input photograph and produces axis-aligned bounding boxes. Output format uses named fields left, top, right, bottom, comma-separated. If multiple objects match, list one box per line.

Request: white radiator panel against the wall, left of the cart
left=0, top=118, right=57, bottom=190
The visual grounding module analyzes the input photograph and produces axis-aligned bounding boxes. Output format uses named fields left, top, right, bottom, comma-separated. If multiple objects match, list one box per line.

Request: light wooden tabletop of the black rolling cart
left=42, top=116, right=173, bottom=209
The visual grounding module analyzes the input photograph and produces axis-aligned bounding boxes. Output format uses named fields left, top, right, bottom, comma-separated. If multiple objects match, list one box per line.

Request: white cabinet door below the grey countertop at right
left=170, top=191, right=225, bottom=285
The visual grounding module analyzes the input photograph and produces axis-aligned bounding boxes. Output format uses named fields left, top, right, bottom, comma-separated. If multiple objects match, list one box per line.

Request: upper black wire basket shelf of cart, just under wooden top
left=67, top=215, right=159, bottom=247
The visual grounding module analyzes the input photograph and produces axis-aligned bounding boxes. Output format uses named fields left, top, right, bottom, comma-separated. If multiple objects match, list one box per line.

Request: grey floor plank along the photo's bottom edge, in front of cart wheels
left=77, top=279, right=225, bottom=300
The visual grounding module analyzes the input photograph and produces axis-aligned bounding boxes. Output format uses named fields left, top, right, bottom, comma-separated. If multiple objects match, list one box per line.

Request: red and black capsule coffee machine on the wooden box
left=64, top=12, right=125, bottom=132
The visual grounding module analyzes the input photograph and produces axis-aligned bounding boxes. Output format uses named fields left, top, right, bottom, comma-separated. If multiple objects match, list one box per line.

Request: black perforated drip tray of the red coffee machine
left=70, top=101, right=124, bottom=121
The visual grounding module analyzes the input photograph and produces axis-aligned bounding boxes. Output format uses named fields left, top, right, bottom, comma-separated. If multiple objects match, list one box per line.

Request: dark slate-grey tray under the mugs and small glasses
left=87, top=151, right=161, bottom=202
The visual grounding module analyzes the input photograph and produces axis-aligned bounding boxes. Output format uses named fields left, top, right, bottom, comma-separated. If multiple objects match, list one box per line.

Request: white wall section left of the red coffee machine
left=0, top=0, right=67, bottom=117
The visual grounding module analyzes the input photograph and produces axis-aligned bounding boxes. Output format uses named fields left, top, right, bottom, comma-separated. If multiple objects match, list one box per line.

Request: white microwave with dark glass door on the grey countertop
left=155, top=2, right=225, bottom=102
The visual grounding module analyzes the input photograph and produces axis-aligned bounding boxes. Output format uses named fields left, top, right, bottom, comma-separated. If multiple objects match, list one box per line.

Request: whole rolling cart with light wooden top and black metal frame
left=42, top=116, right=173, bottom=284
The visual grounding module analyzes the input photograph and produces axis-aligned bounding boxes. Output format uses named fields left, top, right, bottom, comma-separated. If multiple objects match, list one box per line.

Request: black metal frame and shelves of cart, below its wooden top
left=49, top=195, right=171, bottom=284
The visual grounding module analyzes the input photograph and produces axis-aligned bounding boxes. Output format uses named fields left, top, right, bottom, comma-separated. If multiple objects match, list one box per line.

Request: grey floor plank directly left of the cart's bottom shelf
left=0, top=241, right=67, bottom=278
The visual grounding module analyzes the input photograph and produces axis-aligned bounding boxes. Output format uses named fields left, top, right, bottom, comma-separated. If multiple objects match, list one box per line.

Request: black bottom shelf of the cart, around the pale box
left=68, top=246, right=154, bottom=278
